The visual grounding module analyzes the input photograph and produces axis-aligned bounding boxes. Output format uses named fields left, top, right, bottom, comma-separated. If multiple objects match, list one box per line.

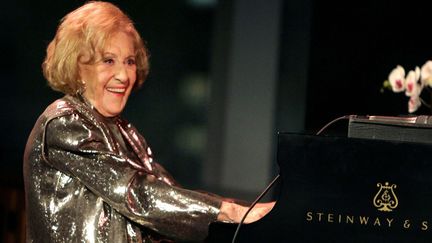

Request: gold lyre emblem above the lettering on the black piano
left=373, top=182, right=399, bottom=212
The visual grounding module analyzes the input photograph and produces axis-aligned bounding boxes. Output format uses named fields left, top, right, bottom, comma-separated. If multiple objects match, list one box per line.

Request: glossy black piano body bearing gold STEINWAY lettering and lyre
left=205, top=123, right=432, bottom=243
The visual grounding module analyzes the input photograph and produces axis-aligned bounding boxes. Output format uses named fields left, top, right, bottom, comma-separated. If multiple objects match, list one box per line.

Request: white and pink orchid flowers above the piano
left=383, top=60, right=432, bottom=113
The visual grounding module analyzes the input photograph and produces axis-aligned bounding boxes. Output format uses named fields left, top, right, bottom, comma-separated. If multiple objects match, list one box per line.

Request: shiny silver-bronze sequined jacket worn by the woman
left=24, top=95, right=221, bottom=243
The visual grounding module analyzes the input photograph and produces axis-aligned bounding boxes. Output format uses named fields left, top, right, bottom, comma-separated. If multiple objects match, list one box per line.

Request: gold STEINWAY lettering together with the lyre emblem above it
left=306, top=182, right=429, bottom=231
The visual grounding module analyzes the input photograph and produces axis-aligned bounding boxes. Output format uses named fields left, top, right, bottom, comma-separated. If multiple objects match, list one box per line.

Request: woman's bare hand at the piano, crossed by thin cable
left=218, top=201, right=275, bottom=223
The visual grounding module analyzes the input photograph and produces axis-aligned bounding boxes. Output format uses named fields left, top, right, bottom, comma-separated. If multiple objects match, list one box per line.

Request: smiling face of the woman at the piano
left=79, top=32, right=136, bottom=117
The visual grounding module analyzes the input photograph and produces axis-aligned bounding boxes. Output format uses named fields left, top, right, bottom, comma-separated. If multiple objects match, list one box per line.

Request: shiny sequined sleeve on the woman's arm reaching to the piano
left=44, top=114, right=221, bottom=240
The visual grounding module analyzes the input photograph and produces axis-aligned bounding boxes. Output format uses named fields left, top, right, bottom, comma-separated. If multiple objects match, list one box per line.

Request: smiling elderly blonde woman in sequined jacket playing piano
left=24, top=2, right=273, bottom=243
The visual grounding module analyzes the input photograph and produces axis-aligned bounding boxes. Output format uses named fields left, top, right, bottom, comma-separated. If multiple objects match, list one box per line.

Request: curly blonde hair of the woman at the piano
left=42, top=1, right=149, bottom=94
